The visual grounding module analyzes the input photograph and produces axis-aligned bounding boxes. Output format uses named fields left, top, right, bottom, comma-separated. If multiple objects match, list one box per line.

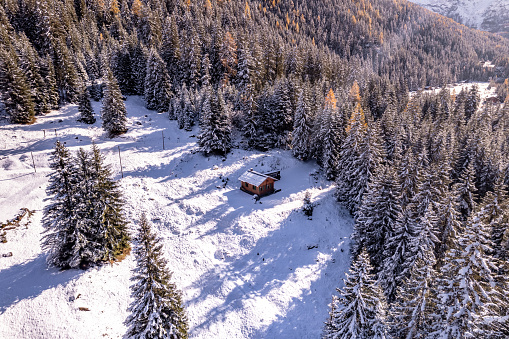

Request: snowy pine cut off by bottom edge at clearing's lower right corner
left=322, top=250, right=388, bottom=339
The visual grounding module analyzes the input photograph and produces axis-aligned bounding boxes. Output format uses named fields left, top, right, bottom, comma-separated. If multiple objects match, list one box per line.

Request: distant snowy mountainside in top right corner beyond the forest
left=412, top=0, right=509, bottom=33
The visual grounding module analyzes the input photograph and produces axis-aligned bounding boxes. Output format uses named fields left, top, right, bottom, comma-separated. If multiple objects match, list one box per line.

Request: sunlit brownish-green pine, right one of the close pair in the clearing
left=90, top=143, right=130, bottom=261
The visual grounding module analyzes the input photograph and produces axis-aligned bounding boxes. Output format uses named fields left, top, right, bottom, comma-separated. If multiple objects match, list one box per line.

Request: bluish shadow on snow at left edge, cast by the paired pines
left=0, top=254, right=83, bottom=314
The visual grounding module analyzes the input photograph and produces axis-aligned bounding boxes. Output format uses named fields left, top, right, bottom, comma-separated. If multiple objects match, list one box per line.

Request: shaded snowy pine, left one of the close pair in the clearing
left=42, top=141, right=93, bottom=269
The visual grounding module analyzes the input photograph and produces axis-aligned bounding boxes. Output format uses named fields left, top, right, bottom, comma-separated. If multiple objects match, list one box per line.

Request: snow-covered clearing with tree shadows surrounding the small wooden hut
left=0, top=97, right=353, bottom=339
